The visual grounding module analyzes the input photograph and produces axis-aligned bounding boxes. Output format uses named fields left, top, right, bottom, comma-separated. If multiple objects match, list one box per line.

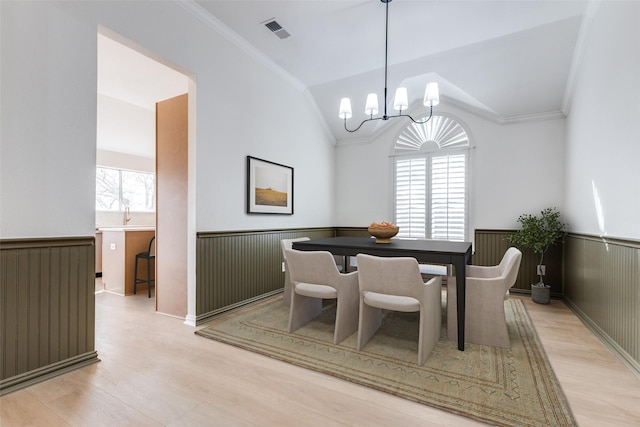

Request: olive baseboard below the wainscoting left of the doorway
left=0, top=351, right=100, bottom=396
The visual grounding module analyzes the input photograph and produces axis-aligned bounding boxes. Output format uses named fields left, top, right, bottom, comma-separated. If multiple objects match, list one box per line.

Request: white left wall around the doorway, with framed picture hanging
left=0, top=1, right=333, bottom=238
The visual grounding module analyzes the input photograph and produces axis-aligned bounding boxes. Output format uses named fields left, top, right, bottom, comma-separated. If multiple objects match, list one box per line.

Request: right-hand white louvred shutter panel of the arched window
left=430, top=153, right=467, bottom=241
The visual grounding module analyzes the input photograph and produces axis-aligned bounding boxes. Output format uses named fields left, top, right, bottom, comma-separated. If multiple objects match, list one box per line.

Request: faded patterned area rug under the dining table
left=196, top=298, right=576, bottom=427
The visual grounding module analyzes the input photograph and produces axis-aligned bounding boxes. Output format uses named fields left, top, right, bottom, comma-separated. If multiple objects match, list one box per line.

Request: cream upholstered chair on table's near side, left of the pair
left=286, top=249, right=358, bottom=344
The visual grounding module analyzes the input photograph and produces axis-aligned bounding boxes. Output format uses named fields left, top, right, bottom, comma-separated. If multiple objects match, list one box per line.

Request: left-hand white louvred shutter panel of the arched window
left=396, top=157, right=427, bottom=238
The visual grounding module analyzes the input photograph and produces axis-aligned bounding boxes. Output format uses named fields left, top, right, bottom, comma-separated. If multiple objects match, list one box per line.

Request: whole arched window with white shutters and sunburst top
left=394, top=115, right=471, bottom=241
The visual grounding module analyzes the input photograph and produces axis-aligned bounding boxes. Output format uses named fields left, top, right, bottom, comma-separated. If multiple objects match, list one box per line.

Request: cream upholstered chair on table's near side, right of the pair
left=356, top=254, right=442, bottom=366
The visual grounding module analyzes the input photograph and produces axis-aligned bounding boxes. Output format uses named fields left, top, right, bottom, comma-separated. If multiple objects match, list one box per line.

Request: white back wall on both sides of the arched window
left=336, top=103, right=565, bottom=229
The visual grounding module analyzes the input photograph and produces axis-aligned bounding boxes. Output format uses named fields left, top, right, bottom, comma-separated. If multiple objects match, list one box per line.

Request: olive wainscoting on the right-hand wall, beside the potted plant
left=564, top=234, right=640, bottom=376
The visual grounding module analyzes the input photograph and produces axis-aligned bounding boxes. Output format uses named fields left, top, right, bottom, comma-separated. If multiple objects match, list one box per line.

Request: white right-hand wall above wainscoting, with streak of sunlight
left=566, top=1, right=640, bottom=240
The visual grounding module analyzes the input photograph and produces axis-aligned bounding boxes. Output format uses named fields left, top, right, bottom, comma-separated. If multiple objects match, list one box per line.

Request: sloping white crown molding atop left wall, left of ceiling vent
left=174, top=0, right=306, bottom=92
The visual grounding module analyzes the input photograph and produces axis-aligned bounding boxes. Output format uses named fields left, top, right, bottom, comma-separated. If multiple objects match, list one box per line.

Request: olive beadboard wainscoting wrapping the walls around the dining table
left=196, top=227, right=640, bottom=373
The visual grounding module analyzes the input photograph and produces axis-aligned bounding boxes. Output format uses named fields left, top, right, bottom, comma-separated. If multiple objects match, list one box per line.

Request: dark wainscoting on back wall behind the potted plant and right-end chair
left=473, top=230, right=563, bottom=297
